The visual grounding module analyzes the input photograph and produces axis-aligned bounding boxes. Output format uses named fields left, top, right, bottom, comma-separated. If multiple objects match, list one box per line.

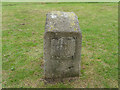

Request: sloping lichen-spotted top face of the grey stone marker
left=45, top=11, right=81, bottom=32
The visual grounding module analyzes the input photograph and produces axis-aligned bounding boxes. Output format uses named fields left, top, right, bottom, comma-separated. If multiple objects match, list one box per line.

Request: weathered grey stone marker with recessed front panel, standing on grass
left=44, top=11, right=82, bottom=78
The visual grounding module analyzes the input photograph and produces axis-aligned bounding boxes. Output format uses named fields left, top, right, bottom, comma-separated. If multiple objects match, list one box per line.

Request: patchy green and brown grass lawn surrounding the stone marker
left=2, top=2, right=118, bottom=88
